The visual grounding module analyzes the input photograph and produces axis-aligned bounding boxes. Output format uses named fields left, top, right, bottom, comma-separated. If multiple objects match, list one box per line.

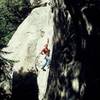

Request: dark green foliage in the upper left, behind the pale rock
left=0, top=0, right=32, bottom=43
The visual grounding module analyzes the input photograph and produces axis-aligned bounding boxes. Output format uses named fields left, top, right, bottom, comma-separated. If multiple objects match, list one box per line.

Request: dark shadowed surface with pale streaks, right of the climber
left=45, top=0, right=100, bottom=100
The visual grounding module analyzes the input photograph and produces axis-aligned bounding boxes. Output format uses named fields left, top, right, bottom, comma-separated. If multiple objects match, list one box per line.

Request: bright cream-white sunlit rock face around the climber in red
left=3, top=4, right=53, bottom=100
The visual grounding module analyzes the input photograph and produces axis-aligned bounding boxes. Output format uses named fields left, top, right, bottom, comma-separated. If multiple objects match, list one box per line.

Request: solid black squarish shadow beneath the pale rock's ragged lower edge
left=12, top=72, right=38, bottom=100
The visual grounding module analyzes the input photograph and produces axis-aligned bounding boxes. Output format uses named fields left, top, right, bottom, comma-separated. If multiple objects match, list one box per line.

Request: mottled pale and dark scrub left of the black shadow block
left=0, top=38, right=13, bottom=100
